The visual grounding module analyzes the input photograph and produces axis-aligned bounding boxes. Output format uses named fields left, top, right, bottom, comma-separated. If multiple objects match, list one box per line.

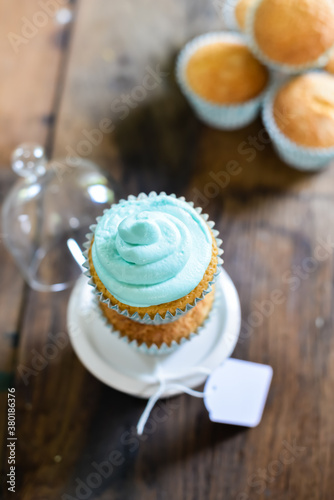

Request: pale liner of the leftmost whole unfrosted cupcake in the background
left=176, top=31, right=269, bottom=130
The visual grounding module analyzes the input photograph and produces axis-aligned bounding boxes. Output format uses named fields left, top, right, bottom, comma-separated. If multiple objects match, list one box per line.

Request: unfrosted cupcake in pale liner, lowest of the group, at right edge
left=263, top=71, right=334, bottom=170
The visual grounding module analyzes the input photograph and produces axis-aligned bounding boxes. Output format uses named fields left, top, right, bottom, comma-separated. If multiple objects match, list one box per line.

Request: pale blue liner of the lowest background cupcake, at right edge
left=263, top=76, right=334, bottom=171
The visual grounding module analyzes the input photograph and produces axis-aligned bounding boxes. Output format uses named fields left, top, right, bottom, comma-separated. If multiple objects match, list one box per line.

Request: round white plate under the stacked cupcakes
left=67, top=270, right=241, bottom=398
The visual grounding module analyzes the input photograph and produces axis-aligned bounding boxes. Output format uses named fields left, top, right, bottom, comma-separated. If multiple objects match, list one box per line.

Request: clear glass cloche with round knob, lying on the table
left=2, top=144, right=115, bottom=291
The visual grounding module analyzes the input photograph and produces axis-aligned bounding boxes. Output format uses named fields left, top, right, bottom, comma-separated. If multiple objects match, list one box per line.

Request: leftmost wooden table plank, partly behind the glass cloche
left=0, top=1, right=74, bottom=376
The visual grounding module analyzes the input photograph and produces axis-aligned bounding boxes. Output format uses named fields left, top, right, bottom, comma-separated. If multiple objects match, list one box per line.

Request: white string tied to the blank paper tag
left=137, top=366, right=212, bottom=436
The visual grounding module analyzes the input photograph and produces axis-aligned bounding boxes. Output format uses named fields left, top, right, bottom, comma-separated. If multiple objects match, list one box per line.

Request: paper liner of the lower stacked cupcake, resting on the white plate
left=96, top=282, right=221, bottom=356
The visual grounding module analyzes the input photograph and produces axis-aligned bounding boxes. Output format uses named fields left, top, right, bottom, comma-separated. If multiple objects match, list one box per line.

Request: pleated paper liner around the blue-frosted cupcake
left=83, top=191, right=224, bottom=325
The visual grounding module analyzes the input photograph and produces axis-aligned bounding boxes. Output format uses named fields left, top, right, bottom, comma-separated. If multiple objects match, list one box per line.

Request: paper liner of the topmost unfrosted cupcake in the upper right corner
left=245, top=0, right=334, bottom=74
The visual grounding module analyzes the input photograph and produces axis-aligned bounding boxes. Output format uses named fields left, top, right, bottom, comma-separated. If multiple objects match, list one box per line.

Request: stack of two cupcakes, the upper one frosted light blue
left=86, top=192, right=222, bottom=349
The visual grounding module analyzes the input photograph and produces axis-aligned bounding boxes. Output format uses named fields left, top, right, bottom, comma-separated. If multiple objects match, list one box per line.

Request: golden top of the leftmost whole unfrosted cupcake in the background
left=186, top=37, right=269, bottom=105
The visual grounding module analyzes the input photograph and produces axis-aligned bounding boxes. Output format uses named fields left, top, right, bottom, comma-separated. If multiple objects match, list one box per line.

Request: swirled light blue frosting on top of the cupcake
left=92, top=194, right=212, bottom=307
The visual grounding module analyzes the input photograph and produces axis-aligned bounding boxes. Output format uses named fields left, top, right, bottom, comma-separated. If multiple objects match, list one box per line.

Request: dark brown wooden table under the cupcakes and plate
left=0, top=0, right=334, bottom=500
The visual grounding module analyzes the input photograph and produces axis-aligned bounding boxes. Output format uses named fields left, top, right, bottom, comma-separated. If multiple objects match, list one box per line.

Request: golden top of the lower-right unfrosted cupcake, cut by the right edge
left=273, top=72, right=334, bottom=148
